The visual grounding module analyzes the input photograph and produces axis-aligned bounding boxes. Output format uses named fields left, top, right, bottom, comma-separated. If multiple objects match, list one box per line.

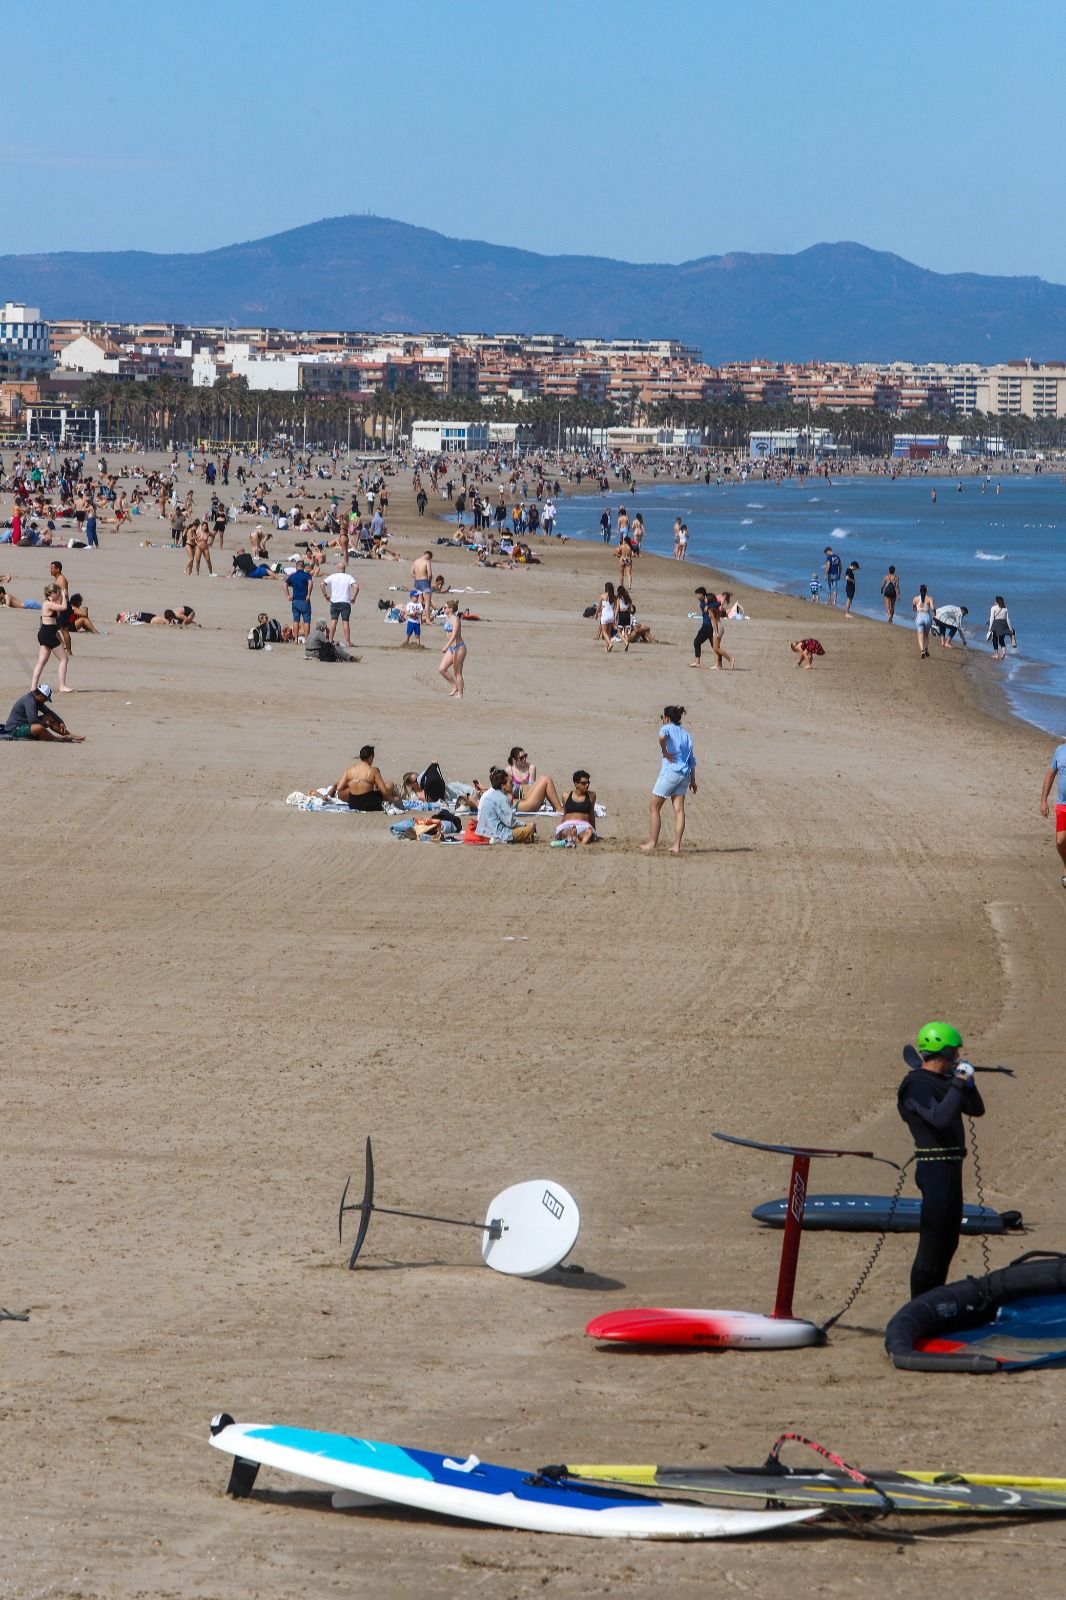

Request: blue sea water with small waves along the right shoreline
left=555, top=472, right=1066, bottom=733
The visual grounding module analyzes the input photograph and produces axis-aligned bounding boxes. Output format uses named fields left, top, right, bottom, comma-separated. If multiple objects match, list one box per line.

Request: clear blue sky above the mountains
left=8, top=0, right=1066, bottom=283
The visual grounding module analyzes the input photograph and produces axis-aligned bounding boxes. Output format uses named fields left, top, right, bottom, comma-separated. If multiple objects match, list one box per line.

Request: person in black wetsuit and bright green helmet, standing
left=896, top=1022, right=984, bottom=1299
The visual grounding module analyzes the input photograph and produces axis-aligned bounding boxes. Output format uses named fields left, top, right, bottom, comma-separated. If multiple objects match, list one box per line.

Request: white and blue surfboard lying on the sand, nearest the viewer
left=211, top=1413, right=820, bottom=1539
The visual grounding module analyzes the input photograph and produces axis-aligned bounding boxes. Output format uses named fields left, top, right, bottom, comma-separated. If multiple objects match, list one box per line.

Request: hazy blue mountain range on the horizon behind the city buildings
left=0, top=216, right=1066, bottom=362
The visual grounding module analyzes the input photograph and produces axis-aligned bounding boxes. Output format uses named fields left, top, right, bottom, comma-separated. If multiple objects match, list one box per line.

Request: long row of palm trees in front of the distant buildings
left=56, top=376, right=1066, bottom=456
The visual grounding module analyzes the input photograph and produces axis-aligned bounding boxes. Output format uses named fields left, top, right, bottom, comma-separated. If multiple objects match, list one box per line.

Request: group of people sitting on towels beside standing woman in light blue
left=311, top=744, right=599, bottom=845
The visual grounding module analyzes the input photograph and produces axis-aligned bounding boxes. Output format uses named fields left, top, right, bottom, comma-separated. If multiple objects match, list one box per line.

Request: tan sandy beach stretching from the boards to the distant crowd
left=0, top=458, right=1066, bottom=1600
